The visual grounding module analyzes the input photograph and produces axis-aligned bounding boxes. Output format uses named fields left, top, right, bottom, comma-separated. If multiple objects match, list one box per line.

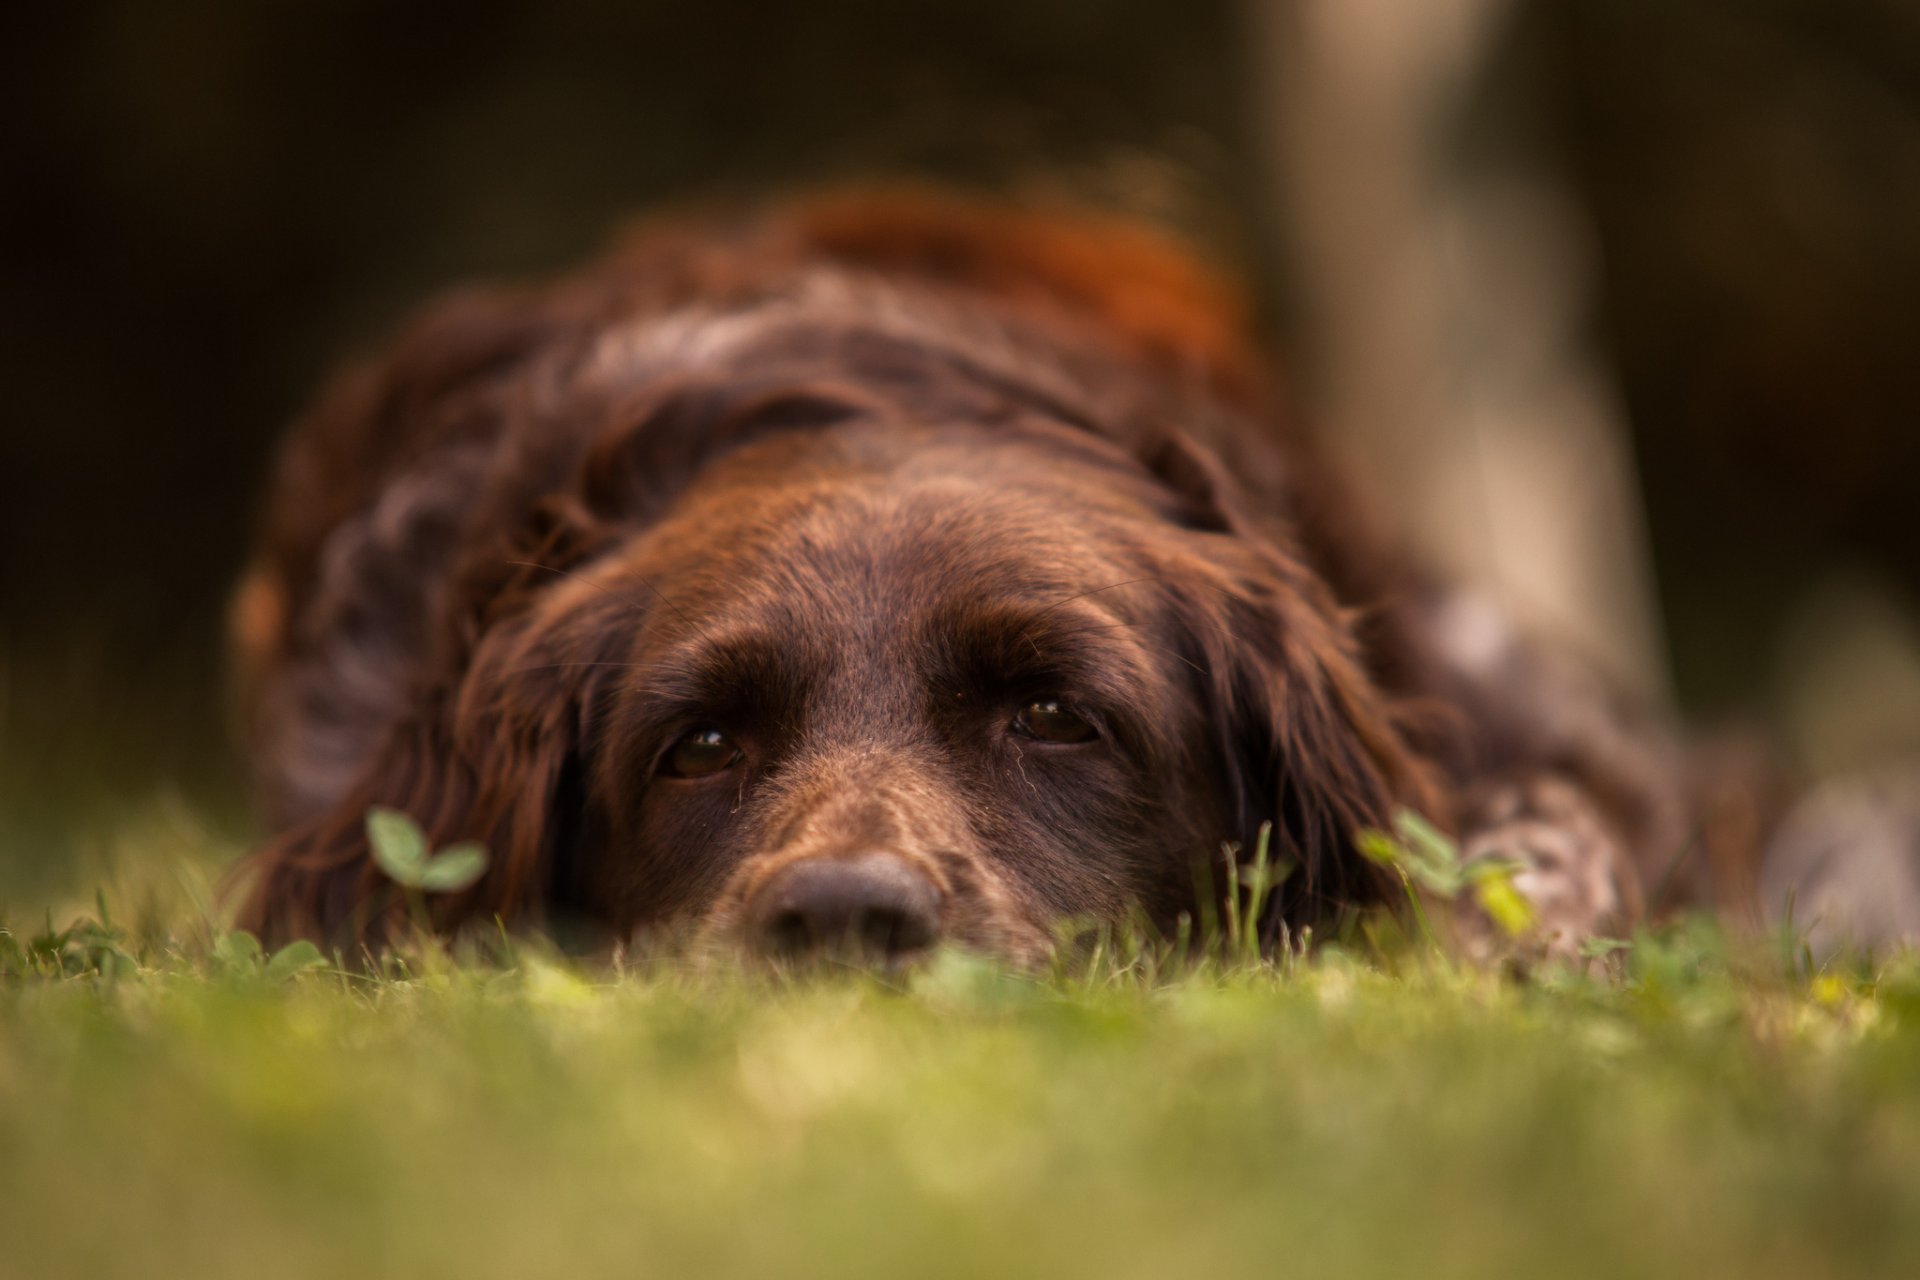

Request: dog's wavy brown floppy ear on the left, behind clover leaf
left=240, top=580, right=643, bottom=946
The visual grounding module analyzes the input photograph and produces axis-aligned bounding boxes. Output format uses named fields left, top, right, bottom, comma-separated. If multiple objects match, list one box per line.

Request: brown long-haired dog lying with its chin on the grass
left=234, top=190, right=1690, bottom=965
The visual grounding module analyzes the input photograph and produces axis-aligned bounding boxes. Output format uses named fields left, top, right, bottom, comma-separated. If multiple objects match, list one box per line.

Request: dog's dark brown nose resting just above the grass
left=747, top=854, right=941, bottom=963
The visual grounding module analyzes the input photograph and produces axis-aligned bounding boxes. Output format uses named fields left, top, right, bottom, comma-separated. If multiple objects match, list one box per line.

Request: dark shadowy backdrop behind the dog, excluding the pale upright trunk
left=0, top=0, right=1920, bottom=894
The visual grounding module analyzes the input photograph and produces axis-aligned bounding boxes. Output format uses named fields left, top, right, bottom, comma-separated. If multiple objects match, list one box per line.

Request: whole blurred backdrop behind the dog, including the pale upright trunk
left=0, top=0, right=1920, bottom=910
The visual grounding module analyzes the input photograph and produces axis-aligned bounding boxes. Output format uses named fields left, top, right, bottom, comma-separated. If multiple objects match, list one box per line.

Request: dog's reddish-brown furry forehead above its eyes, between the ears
left=614, top=426, right=1156, bottom=694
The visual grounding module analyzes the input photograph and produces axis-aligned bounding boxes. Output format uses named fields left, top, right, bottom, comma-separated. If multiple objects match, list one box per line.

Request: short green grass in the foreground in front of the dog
left=0, top=875, right=1920, bottom=1280
